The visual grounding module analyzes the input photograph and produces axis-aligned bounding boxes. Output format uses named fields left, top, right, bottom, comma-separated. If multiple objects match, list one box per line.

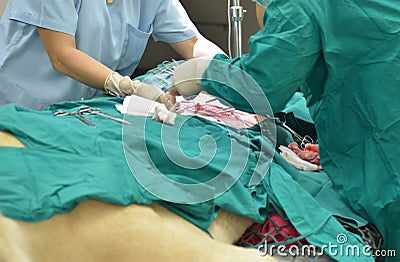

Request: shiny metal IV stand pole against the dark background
left=231, top=0, right=246, bottom=57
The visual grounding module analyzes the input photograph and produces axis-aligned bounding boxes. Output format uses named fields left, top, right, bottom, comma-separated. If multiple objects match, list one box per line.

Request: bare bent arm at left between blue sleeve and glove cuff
left=38, top=28, right=111, bottom=89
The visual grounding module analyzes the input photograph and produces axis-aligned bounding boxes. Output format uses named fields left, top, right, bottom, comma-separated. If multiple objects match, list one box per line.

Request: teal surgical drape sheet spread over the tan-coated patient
left=0, top=98, right=366, bottom=261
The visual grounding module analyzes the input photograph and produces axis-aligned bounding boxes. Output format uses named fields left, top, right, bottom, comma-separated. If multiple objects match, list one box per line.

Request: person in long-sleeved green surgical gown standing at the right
left=173, top=0, right=400, bottom=261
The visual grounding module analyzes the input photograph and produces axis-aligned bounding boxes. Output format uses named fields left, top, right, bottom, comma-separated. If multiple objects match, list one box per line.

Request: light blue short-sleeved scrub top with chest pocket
left=0, top=0, right=198, bottom=109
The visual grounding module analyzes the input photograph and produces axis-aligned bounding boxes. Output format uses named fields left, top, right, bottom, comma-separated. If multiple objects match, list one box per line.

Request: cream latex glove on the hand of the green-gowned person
left=169, top=58, right=210, bottom=99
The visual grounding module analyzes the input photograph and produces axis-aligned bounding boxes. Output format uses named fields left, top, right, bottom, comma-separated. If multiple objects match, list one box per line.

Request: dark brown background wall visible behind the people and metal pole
left=134, top=0, right=259, bottom=76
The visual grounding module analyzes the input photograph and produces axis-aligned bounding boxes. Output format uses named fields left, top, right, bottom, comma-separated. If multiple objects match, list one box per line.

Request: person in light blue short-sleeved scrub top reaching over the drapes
left=0, top=0, right=223, bottom=109
